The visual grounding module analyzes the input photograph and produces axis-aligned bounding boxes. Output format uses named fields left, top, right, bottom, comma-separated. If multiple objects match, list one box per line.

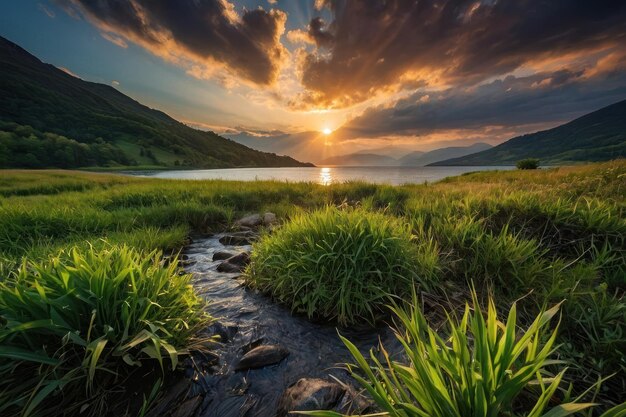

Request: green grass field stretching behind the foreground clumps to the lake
left=0, top=161, right=626, bottom=412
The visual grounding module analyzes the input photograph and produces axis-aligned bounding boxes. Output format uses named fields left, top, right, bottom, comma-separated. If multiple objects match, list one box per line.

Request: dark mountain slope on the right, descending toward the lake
left=432, top=100, right=626, bottom=166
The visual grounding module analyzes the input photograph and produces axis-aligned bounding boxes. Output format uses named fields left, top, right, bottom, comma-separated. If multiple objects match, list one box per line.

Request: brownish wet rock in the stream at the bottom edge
left=277, top=378, right=346, bottom=417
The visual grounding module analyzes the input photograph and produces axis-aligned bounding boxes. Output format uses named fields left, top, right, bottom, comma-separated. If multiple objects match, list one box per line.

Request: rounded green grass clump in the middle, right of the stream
left=241, top=207, right=438, bottom=325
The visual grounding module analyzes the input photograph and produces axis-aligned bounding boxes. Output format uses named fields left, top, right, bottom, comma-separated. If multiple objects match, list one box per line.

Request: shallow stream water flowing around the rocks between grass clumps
left=176, top=234, right=395, bottom=417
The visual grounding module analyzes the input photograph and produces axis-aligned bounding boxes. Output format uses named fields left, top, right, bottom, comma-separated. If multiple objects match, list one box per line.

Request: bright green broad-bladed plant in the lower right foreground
left=314, top=295, right=593, bottom=417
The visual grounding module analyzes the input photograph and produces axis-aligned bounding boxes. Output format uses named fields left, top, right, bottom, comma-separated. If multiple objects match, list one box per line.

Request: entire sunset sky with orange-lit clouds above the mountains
left=0, top=0, right=626, bottom=162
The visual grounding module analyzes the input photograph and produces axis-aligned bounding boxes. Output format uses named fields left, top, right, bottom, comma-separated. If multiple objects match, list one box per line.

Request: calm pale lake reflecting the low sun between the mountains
left=140, top=166, right=515, bottom=185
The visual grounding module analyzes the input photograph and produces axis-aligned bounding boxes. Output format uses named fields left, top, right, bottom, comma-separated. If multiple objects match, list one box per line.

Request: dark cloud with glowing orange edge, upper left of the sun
left=57, top=0, right=286, bottom=85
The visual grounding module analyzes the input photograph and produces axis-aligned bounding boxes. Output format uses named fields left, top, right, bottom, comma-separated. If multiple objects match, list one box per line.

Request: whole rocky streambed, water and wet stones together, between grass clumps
left=151, top=213, right=395, bottom=417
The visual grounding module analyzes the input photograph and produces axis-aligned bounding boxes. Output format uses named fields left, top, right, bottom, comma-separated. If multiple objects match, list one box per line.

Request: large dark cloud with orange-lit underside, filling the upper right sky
left=293, top=0, right=626, bottom=107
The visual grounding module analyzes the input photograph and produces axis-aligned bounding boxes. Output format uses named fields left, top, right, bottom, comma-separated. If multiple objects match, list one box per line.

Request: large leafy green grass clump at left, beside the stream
left=0, top=246, right=210, bottom=416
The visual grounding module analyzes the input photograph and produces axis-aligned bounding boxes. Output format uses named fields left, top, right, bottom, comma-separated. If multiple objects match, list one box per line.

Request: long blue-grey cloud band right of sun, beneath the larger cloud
left=338, top=71, right=626, bottom=138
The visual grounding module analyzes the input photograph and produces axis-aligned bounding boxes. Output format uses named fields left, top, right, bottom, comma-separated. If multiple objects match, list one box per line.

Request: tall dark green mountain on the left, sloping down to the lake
left=0, top=37, right=310, bottom=168
